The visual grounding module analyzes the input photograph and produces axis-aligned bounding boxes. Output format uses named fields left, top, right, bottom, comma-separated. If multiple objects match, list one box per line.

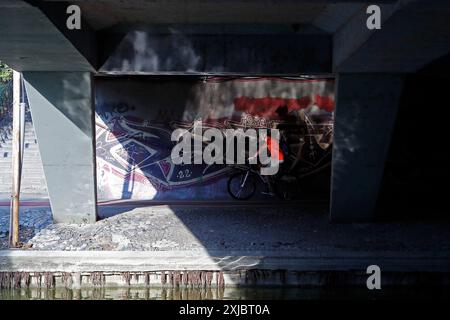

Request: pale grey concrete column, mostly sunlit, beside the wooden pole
left=23, top=72, right=97, bottom=223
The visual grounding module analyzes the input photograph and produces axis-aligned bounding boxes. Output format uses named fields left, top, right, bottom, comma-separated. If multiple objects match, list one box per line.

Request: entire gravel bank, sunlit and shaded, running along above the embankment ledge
left=0, top=206, right=450, bottom=253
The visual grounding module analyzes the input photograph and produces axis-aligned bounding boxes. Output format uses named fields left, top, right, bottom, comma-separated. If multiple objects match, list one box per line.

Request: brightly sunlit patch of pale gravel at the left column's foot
left=28, top=208, right=201, bottom=250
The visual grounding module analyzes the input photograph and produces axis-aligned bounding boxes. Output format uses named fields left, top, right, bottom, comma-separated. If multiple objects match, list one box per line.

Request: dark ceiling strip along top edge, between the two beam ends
left=47, top=0, right=394, bottom=30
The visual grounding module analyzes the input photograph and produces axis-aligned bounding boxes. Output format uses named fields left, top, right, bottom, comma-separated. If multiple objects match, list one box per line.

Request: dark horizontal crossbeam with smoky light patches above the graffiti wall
left=99, top=26, right=331, bottom=75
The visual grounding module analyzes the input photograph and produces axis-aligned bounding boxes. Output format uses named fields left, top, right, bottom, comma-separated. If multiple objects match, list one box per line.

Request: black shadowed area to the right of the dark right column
left=378, top=73, right=450, bottom=220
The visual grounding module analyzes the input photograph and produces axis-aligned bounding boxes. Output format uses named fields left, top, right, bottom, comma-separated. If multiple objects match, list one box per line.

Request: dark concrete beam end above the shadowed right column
left=333, top=0, right=450, bottom=73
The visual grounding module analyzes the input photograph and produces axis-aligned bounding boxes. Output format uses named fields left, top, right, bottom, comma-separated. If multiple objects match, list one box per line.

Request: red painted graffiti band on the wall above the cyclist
left=234, top=95, right=334, bottom=118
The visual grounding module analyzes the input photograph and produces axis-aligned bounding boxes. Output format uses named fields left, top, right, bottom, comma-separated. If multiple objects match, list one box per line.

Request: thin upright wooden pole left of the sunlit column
left=9, top=71, right=22, bottom=247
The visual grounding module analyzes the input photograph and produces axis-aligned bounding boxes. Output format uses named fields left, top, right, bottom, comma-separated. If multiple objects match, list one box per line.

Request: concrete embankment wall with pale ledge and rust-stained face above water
left=0, top=251, right=450, bottom=288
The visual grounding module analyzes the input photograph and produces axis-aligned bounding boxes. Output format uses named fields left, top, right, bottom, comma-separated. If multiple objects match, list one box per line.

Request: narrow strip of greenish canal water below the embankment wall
left=0, top=287, right=450, bottom=300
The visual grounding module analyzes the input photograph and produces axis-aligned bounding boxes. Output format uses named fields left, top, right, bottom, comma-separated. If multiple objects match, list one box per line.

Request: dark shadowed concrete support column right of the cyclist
left=330, top=74, right=403, bottom=222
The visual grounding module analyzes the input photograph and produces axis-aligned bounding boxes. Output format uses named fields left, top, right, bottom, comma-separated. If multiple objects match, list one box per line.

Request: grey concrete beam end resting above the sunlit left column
left=0, top=0, right=96, bottom=71
